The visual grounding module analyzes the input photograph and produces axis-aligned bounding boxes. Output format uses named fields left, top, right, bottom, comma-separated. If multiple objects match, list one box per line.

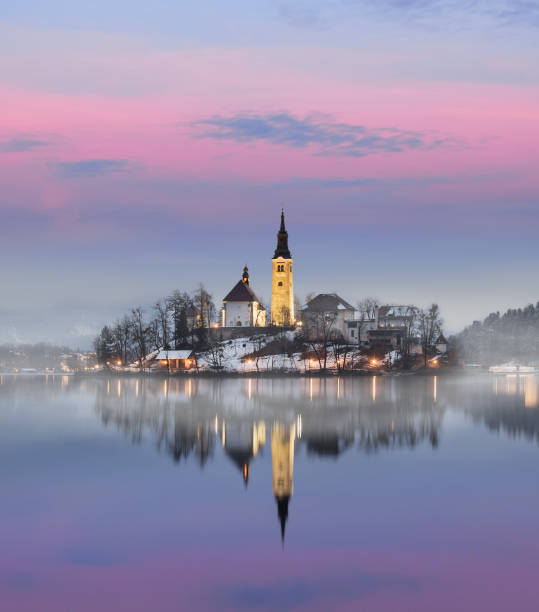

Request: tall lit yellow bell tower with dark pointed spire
left=271, top=210, right=295, bottom=327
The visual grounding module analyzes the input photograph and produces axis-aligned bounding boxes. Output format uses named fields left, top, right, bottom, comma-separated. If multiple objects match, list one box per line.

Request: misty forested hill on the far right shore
left=454, top=302, right=539, bottom=365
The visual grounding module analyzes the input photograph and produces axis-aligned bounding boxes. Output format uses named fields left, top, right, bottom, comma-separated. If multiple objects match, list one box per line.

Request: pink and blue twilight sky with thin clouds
left=0, top=0, right=539, bottom=348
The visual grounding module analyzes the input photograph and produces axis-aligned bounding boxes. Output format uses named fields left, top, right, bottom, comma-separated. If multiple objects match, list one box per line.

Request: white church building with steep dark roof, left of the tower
left=221, top=266, right=266, bottom=327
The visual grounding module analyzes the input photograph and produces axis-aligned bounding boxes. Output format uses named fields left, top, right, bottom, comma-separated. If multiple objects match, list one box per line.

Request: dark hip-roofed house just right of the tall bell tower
left=301, top=293, right=357, bottom=342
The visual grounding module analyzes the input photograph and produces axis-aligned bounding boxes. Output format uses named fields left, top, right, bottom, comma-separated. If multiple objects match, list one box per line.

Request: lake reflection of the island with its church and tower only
left=92, top=372, right=443, bottom=542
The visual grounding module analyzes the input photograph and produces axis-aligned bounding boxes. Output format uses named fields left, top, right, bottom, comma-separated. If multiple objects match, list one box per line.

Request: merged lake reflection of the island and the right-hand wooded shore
left=75, top=376, right=539, bottom=542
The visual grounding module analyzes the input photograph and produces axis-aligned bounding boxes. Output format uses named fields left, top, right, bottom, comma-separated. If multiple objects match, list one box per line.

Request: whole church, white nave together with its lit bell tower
left=221, top=210, right=296, bottom=328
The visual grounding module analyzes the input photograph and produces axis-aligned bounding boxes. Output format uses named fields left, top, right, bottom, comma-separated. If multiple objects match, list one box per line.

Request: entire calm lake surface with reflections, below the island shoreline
left=0, top=375, right=539, bottom=612
